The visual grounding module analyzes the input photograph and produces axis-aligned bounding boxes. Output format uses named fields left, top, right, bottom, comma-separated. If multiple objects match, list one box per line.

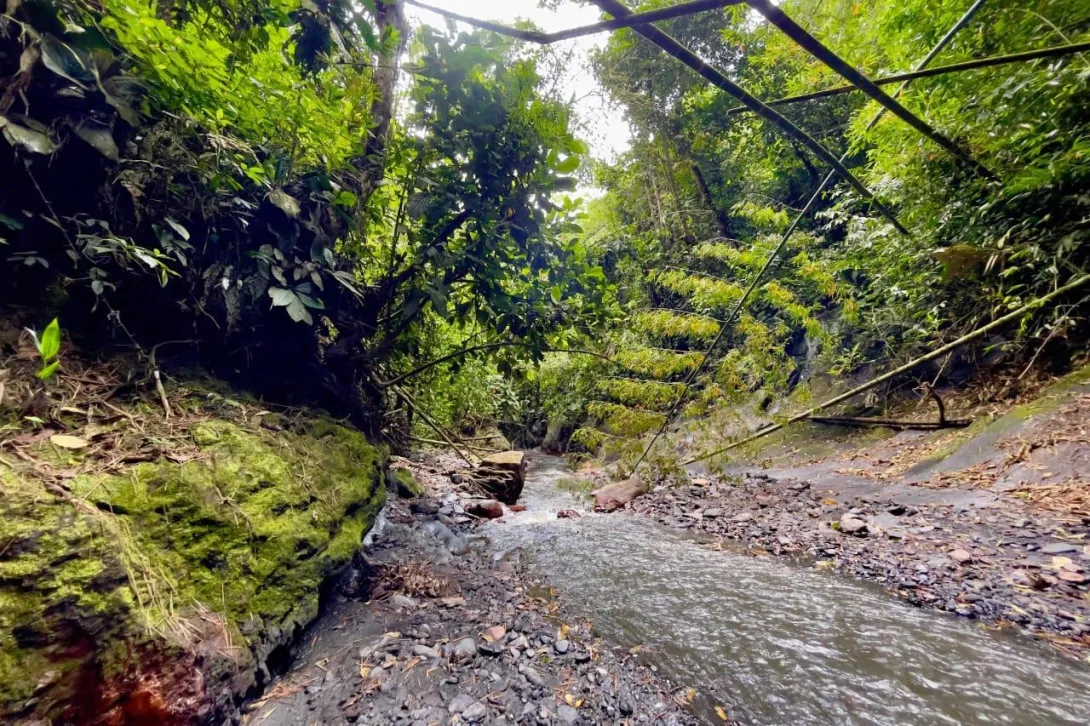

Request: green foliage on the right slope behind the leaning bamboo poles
left=542, top=0, right=1090, bottom=464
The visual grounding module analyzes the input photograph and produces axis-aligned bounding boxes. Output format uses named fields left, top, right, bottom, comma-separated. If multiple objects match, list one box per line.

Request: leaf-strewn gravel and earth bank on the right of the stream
left=627, top=380, right=1090, bottom=660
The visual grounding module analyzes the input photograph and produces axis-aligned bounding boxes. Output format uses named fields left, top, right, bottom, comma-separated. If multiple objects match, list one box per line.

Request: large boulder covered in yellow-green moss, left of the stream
left=0, top=420, right=386, bottom=723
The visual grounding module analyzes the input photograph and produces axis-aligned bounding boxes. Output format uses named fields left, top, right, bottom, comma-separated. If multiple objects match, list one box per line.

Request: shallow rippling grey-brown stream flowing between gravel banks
left=488, top=458, right=1090, bottom=725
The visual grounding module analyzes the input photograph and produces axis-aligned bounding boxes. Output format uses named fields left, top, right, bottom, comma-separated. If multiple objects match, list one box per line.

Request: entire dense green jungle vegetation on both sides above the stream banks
left=0, top=0, right=1090, bottom=468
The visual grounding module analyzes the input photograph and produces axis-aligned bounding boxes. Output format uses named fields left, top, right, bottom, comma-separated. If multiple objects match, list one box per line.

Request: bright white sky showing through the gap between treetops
left=405, top=0, right=631, bottom=160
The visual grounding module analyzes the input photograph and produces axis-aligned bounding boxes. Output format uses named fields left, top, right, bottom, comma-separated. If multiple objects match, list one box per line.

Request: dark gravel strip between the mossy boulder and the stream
left=246, top=459, right=697, bottom=726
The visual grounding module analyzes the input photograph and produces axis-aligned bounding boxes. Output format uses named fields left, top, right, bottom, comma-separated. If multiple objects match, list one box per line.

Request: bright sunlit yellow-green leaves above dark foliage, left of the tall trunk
left=102, top=0, right=375, bottom=174
